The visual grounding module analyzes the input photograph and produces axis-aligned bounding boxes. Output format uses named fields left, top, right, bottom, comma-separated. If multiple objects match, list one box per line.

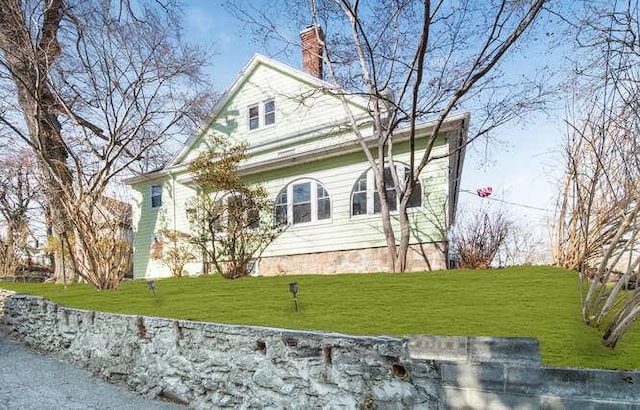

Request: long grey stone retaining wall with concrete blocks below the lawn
left=0, top=290, right=640, bottom=409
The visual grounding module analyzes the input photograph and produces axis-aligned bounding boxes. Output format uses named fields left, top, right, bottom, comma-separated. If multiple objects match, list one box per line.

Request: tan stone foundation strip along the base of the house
left=258, top=242, right=446, bottom=276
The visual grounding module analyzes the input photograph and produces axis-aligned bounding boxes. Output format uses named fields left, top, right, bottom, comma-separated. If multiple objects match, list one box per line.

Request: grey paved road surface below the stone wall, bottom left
left=0, top=337, right=181, bottom=410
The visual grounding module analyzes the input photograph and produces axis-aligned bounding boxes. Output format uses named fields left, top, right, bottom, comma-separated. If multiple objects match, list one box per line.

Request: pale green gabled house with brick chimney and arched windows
left=127, top=30, right=469, bottom=278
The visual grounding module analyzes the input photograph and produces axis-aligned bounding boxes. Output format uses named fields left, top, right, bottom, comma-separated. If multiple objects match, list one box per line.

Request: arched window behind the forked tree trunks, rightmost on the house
left=351, top=164, right=422, bottom=216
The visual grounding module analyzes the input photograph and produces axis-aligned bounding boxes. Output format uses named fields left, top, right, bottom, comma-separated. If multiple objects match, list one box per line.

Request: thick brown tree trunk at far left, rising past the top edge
left=0, top=0, right=73, bottom=279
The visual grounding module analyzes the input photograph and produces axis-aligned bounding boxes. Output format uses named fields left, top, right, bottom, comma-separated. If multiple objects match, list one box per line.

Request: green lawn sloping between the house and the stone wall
left=0, top=267, right=640, bottom=369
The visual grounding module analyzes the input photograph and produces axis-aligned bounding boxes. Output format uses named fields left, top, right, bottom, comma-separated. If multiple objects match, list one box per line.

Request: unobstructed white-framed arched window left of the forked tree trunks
left=275, top=180, right=331, bottom=225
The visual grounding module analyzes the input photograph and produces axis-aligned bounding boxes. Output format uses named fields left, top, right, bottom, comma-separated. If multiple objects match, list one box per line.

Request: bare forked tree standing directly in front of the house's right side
left=229, top=0, right=547, bottom=271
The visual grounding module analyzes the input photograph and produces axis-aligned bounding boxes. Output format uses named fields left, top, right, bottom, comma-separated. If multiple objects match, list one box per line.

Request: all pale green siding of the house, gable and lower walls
left=129, top=53, right=460, bottom=277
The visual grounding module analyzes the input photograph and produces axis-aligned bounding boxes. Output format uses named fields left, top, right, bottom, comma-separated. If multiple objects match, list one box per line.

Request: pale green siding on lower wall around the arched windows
left=250, top=143, right=447, bottom=256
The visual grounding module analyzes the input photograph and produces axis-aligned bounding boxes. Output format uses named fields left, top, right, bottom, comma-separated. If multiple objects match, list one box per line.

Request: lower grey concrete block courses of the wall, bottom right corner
left=440, top=362, right=640, bottom=410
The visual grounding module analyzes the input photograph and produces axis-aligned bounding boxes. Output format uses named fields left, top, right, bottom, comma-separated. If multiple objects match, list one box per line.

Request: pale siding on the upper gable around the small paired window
left=184, top=59, right=370, bottom=163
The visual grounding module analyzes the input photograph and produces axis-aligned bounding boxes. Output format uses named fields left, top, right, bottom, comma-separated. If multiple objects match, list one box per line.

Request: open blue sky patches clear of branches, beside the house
left=183, top=0, right=563, bottom=262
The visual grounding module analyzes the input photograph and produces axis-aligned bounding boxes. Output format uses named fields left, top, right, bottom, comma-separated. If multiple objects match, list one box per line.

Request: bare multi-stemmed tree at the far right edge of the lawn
left=554, top=1, right=640, bottom=348
